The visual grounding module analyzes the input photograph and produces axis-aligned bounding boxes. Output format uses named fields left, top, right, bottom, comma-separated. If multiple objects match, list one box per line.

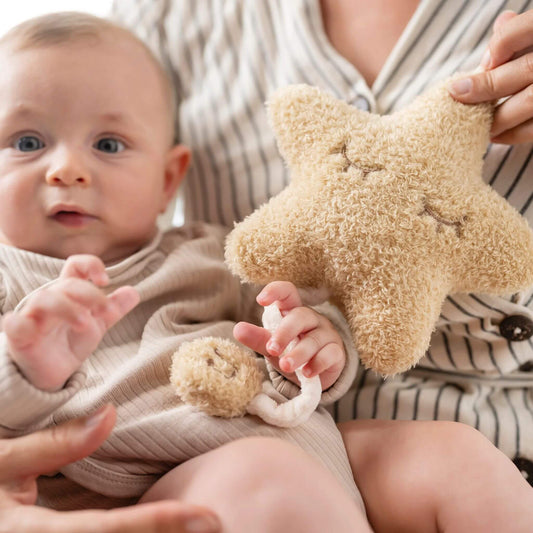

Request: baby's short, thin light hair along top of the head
left=0, top=11, right=179, bottom=143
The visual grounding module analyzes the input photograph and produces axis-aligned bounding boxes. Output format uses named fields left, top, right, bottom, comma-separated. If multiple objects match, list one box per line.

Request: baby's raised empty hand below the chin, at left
left=2, top=255, right=139, bottom=391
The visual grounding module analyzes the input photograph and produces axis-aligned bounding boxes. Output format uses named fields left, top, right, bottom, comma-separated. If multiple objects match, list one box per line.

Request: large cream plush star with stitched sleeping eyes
left=226, top=84, right=533, bottom=375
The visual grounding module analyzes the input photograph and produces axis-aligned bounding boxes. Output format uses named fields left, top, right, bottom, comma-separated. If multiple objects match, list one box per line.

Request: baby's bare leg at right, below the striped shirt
left=339, top=420, right=533, bottom=533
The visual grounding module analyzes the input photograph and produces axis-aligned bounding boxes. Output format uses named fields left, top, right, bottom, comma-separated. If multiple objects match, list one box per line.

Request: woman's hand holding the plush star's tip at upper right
left=449, top=10, right=533, bottom=144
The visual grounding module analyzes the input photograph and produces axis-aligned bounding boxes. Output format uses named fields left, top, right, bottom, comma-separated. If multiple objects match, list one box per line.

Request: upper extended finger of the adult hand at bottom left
left=0, top=405, right=116, bottom=485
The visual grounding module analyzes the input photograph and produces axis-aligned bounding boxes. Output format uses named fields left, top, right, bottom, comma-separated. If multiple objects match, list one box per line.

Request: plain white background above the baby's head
left=0, top=0, right=111, bottom=35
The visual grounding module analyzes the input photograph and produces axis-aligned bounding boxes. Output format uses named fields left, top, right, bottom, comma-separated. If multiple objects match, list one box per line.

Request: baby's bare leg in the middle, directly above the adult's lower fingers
left=141, top=437, right=371, bottom=533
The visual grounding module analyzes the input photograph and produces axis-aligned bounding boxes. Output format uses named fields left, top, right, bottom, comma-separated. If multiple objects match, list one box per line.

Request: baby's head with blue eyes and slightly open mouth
left=0, top=13, right=189, bottom=262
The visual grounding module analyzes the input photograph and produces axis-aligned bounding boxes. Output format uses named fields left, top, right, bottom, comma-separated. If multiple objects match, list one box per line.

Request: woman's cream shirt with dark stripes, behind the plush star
left=114, top=0, right=533, bottom=482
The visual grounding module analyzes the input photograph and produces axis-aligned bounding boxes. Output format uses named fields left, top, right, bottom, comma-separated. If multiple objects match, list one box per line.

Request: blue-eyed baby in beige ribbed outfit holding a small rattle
left=0, top=13, right=369, bottom=532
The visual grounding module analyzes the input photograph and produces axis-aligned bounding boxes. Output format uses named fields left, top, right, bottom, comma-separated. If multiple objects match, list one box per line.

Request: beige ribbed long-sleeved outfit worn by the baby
left=0, top=224, right=361, bottom=507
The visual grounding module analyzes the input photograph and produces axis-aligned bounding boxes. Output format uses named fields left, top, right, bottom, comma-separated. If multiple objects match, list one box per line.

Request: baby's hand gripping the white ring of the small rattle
left=233, top=281, right=346, bottom=390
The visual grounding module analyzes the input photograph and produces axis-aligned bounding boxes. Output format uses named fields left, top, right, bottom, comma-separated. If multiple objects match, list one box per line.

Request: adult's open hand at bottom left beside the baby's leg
left=0, top=405, right=220, bottom=533
